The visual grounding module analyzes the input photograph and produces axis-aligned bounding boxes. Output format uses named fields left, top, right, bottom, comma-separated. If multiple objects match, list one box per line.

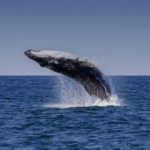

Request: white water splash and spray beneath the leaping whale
left=43, top=76, right=121, bottom=108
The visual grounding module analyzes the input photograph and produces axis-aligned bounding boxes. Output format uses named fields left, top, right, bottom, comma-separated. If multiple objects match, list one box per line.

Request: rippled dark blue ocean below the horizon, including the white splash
left=0, top=76, right=150, bottom=150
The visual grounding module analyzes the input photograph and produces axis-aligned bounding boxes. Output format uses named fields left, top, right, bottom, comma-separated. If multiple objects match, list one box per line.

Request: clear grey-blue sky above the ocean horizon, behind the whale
left=0, top=0, right=150, bottom=75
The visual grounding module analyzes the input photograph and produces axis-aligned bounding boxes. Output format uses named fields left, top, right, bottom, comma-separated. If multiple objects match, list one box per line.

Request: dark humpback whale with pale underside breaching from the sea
left=25, top=49, right=111, bottom=101
